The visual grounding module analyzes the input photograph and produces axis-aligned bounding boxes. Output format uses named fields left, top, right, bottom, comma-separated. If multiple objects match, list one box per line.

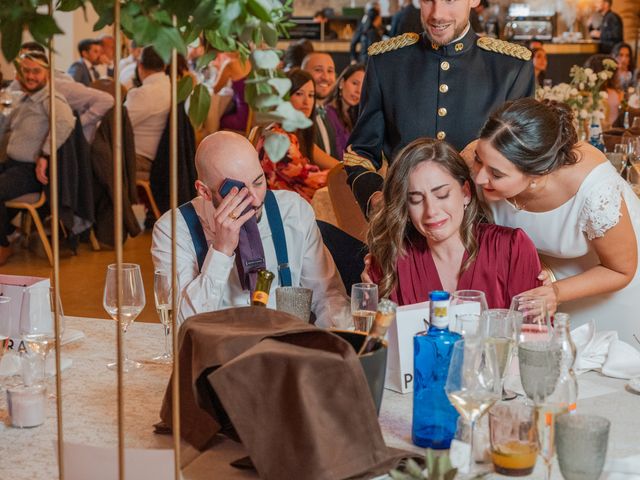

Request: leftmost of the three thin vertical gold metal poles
left=49, top=0, right=64, bottom=480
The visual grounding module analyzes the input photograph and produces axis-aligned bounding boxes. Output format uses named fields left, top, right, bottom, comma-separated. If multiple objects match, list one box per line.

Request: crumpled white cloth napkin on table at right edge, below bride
left=571, top=320, right=640, bottom=379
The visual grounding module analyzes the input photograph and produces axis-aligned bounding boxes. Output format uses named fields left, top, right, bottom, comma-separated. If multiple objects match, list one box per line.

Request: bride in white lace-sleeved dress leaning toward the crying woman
left=463, top=98, right=640, bottom=342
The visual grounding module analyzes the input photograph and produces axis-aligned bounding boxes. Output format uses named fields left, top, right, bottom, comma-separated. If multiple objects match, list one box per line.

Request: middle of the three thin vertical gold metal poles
left=113, top=0, right=125, bottom=480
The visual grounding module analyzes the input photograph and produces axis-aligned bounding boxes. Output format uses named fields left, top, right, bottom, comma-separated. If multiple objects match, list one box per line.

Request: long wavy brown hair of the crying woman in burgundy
left=367, top=138, right=483, bottom=297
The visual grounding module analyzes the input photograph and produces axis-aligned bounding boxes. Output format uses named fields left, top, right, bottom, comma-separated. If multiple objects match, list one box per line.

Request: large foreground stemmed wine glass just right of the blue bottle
left=444, top=337, right=501, bottom=474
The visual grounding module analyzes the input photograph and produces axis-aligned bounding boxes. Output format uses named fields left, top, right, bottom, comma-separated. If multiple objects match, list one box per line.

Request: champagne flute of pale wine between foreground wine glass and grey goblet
left=480, top=308, right=522, bottom=400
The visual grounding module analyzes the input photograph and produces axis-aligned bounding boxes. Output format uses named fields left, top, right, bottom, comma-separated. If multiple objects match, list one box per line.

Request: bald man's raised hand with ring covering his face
left=213, top=187, right=256, bottom=257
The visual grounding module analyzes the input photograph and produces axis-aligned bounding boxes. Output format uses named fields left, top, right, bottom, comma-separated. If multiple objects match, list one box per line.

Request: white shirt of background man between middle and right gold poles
left=124, top=72, right=171, bottom=160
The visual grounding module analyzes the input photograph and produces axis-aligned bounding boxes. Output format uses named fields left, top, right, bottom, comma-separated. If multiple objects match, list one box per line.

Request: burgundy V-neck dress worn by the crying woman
left=371, top=223, right=542, bottom=308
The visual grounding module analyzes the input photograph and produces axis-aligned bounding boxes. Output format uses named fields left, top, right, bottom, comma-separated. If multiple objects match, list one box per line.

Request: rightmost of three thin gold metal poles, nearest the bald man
left=169, top=17, right=181, bottom=480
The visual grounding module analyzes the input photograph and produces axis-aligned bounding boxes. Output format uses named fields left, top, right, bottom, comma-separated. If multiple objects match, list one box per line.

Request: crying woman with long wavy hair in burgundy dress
left=367, top=138, right=541, bottom=308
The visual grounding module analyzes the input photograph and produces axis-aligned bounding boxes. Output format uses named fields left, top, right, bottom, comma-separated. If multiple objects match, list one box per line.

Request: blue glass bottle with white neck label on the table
left=411, top=290, right=462, bottom=449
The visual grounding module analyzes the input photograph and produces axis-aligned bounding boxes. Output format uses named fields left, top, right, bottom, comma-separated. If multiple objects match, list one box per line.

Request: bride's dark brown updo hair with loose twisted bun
left=480, top=98, right=578, bottom=175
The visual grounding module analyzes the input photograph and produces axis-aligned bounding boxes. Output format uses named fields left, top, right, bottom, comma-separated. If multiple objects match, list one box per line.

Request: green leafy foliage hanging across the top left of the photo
left=0, top=0, right=298, bottom=159
